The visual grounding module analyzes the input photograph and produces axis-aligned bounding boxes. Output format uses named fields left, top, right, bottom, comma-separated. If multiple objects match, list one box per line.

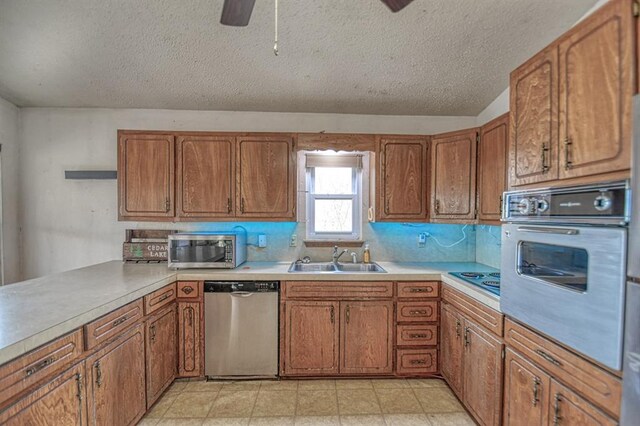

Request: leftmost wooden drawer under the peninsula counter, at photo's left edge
left=0, top=329, right=82, bottom=406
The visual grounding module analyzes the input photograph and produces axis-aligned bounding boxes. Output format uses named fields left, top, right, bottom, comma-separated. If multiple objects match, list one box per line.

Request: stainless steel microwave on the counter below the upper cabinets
left=168, top=232, right=247, bottom=269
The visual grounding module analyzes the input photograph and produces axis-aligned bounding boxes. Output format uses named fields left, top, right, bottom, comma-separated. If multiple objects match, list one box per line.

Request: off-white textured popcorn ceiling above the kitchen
left=0, top=0, right=596, bottom=115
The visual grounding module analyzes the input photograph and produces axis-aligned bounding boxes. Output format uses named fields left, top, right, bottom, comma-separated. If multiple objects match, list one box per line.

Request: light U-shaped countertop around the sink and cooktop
left=0, top=260, right=500, bottom=364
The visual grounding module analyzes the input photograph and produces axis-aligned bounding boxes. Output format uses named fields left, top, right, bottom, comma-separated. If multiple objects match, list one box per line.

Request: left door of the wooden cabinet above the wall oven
left=509, top=46, right=558, bottom=186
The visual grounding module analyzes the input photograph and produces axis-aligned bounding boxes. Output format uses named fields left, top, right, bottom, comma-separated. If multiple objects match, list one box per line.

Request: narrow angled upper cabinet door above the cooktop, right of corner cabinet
left=478, top=114, right=509, bottom=223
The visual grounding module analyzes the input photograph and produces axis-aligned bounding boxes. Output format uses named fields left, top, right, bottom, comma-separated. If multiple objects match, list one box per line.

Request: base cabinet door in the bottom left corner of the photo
left=0, top=363, right=88, bottom=426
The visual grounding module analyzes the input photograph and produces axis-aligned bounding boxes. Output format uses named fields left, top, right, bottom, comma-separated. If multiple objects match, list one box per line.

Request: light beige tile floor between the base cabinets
left=139, top=379, right=475, bottom=426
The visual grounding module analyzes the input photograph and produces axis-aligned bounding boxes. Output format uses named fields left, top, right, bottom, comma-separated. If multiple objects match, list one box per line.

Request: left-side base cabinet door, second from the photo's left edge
left=84, top=324, right=147, bottom=426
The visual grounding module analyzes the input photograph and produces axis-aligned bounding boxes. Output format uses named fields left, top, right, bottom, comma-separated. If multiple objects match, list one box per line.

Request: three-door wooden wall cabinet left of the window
left=118, top=131, right=296, bottom=221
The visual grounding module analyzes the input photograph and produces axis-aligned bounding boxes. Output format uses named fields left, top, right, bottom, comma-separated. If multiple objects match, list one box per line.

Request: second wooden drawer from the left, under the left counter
left=84, top=299, right=143, bottom=350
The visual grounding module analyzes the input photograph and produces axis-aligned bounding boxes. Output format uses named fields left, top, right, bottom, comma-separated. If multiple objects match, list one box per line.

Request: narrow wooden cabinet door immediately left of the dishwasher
left=178, top=302, right=204, bottom=377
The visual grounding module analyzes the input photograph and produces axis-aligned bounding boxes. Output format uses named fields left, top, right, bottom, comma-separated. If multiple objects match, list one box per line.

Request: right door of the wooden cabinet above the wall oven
left=559, top=0, right=635, bottom=178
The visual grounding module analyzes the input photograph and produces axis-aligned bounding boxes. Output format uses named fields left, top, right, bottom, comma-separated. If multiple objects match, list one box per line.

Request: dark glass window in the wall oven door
left=517, top=241, right=589, bottom=292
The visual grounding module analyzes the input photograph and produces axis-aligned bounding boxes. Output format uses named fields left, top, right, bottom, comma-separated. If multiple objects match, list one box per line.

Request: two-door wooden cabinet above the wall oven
left=509, top=0, right=636, bottom=186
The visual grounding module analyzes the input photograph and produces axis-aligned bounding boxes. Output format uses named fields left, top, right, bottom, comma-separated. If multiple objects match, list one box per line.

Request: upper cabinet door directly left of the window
left=236, top=136, right=295, bottom=220
